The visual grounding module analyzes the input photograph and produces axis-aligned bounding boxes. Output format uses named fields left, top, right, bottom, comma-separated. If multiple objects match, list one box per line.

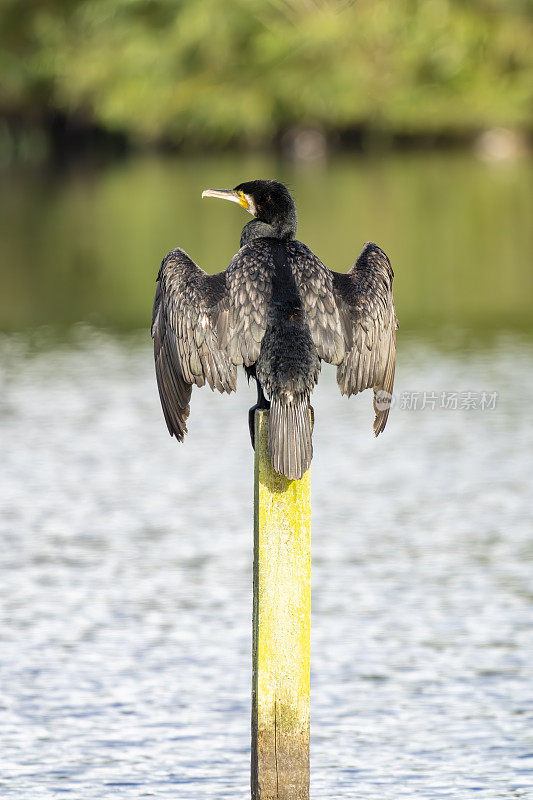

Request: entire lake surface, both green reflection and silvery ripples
left=0, top=156, right=533, bottom=800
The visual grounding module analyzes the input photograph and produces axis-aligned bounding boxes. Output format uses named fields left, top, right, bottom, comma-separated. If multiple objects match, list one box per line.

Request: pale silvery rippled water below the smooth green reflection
left=0, top=329, right=533, bottom=800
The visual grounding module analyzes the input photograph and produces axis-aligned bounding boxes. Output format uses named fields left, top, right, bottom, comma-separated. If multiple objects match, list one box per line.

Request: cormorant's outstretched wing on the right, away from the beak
left=332, top=242, right=398, bottom=436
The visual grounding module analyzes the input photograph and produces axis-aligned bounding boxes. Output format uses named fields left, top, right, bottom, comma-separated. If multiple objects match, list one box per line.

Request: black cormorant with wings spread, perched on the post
left=152, top=180, right=397, bottom=478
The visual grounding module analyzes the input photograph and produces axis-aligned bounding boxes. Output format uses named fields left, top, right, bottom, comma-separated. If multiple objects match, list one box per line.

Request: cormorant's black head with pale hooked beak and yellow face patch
left=202, top=180, right=297, bottom=239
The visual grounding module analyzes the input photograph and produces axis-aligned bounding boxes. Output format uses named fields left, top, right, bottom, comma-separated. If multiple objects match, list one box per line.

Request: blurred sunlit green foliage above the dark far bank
left=0, top=0, right=533, bottom=146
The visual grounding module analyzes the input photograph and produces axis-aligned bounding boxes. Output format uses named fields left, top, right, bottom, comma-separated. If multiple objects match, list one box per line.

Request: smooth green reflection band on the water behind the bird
left=0, top=155, right=533, bottom=335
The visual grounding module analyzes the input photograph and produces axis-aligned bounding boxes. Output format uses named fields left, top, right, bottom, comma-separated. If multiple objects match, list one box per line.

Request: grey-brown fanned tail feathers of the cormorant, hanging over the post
left=268, top=395, right=313, bottom=480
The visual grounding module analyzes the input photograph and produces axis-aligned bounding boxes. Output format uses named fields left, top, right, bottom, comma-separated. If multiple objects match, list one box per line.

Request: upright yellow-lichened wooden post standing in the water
left=252, top=411, right=311, bottom=800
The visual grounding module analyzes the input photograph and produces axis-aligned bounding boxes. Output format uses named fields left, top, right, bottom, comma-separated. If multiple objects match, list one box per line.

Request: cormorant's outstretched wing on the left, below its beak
left=152, top=248, right=237, bottom=441
